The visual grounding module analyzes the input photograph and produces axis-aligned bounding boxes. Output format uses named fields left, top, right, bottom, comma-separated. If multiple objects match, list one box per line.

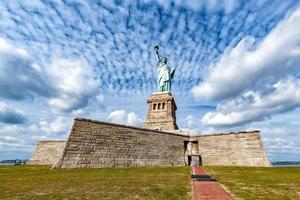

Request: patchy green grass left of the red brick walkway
left=0, top=166, right=191, bottom=199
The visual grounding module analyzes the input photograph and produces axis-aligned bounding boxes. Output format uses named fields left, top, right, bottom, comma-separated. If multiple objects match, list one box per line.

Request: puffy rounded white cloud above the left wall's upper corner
left=46, top=58, right=98, bottom=111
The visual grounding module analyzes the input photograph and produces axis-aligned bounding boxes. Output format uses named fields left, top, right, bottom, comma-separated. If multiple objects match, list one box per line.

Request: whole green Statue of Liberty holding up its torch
left=154, top=45, right=175, bottom=92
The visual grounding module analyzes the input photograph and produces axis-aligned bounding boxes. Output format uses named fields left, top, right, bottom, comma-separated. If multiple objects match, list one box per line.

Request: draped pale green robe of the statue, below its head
left=157, top=61, right=172, bottom=92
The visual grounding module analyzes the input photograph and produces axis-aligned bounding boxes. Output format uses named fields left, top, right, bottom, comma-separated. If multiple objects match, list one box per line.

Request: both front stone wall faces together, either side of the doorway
left=52, top=118, right=269, bottom=168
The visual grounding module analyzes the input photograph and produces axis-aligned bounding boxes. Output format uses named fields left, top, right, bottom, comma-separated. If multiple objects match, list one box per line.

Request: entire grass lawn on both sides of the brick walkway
left=0, top=166, right=300, bottom=200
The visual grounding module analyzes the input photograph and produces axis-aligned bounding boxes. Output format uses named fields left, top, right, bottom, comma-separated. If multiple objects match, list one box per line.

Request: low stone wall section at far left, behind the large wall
left=26, top=140, right=67, bottom=165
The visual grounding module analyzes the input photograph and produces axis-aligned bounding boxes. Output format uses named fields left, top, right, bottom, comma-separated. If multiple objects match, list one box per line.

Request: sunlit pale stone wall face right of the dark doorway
left=191, top=131, right=270, bottom=166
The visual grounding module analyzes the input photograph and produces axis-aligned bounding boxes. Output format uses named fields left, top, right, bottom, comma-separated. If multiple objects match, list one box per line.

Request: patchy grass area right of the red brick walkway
left=205, top=167, right=300, bottom=200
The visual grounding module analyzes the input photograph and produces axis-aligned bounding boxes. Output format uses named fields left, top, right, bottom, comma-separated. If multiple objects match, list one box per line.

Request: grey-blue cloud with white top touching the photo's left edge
left=0, top=38, right=49, bottom=100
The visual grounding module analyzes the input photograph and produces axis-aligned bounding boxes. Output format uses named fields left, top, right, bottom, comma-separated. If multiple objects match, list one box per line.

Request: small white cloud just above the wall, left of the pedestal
left=107, top=109, right=142, bottom=126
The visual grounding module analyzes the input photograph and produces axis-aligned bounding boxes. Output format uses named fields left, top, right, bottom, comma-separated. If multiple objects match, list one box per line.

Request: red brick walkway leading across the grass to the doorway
left=192, top=166, right=233, bottom=200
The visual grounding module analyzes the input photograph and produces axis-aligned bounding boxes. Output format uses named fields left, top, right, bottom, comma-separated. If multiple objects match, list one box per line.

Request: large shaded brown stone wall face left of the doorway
left=54, top=118, right=189, bottom=168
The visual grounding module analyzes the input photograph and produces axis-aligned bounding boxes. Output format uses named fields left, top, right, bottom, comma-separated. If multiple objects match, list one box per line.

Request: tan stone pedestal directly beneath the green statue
left=144, top=92, right=178, bottom=130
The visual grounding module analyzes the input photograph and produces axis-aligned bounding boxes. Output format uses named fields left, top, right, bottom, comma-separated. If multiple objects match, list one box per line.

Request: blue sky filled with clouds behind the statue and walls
left=0, top=0, right=300, bottom=161
